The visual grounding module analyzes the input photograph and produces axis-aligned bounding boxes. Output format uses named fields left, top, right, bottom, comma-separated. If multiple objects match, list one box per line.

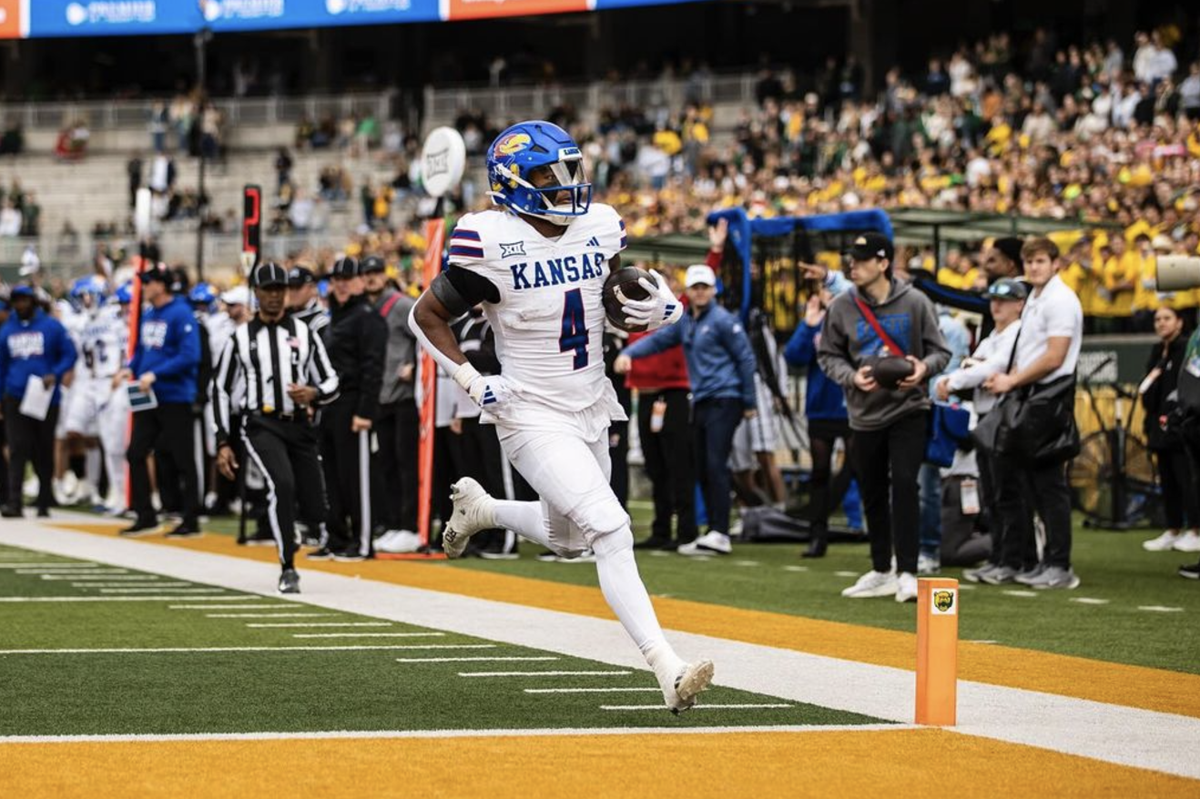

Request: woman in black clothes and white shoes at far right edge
left=1138, top=306, right=1200, bottom=552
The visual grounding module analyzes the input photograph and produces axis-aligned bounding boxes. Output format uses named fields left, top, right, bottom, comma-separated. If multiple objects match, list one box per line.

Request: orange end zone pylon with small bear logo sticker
left=917, top=578, right=960, bottom=727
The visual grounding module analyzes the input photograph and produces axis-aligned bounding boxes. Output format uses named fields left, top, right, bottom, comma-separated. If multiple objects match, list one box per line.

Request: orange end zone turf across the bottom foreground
left=0, top=729, right=1200, bottom=799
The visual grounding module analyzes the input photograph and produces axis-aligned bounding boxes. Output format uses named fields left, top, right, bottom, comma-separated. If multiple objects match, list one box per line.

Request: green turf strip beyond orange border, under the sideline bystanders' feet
left=187, top=503, right=1200, bottom=674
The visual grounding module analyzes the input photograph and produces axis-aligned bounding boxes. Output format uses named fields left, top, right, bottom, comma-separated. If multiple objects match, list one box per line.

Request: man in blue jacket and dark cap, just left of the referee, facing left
left=113, top=266, right=200, bottom=539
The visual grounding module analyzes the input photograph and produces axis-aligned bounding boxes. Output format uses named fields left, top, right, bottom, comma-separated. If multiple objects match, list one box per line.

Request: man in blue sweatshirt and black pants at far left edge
left=0, top=284, right=76, bottom=518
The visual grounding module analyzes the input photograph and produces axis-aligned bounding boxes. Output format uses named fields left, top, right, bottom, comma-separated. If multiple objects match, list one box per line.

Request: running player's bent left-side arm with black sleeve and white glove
left=408, top=264, right=503, bottom=405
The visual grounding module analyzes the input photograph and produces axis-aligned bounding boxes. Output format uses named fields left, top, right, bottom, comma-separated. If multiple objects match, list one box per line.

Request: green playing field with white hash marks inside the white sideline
left=0, top=547, right=878, bottom=735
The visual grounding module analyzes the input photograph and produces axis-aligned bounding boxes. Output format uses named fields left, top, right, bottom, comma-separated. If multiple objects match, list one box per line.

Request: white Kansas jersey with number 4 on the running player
left=450, top=203, right=625, bottom=417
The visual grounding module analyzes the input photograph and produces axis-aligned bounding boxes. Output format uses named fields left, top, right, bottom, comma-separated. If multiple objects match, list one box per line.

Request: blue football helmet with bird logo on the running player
left=487, top=120, right=592, bottom=227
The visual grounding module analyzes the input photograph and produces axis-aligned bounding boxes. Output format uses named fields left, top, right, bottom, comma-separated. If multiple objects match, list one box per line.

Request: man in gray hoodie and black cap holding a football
left=817, top=233, right=950, bottom=602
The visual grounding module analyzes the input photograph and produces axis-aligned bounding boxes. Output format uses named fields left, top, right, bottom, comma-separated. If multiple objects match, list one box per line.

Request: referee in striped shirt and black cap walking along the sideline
left=212, top=263, right=338, bottom=594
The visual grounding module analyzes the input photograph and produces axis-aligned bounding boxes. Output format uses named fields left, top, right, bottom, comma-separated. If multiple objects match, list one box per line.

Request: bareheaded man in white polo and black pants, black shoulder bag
left=984, top=238, right=1084, bottom=589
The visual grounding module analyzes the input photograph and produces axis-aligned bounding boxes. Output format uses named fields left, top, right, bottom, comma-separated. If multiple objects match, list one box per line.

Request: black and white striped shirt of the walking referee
left=211, top=316, right=337, bottom=444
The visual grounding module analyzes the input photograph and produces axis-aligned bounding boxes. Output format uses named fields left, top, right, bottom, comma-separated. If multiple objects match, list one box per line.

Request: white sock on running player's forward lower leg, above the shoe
left=592, top=527, right=683, bottom=675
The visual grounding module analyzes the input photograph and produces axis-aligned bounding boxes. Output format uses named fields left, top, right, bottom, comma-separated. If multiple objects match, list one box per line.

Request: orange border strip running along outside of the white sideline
left=54, top=522, right=1200, bottom=717
